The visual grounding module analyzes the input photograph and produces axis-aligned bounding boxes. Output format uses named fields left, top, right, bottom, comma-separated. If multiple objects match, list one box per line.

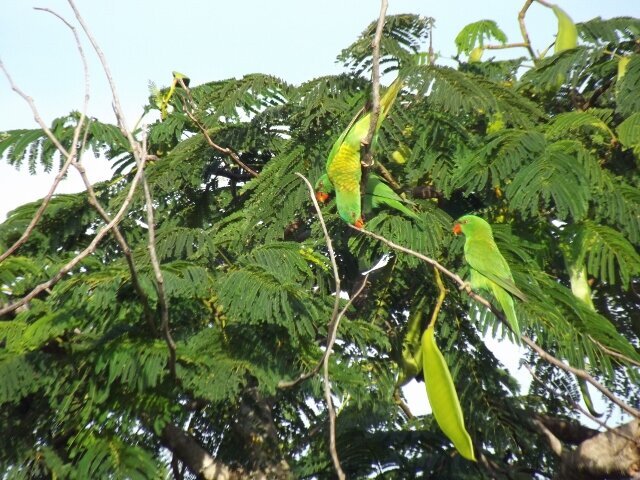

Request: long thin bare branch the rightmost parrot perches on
left=349, top=225, right=640, bottom=418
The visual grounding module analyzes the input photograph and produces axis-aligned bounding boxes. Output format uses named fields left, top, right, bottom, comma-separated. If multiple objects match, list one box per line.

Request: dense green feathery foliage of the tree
left=0, top=7, right=640, bottom=479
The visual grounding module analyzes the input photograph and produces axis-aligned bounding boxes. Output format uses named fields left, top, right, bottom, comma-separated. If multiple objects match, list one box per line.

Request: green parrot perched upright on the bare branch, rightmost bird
left=453, top=215, right=526, bottom=339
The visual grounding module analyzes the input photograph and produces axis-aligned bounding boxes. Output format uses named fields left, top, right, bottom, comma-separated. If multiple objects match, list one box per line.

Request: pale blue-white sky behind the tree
left=0, top=0, right=640, bottom=413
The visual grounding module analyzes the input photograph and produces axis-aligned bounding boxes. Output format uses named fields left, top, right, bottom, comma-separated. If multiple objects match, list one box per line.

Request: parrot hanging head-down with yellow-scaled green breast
left=326, top=77, right=402, bottom=228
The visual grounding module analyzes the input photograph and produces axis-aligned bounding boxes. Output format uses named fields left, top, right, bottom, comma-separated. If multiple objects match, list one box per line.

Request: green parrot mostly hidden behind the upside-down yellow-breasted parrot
left=315, top=173, right=420, bottom=220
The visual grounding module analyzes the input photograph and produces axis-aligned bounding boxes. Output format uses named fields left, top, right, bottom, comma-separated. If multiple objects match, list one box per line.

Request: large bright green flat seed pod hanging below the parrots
left=422, top=325, right=476, bottom=462
